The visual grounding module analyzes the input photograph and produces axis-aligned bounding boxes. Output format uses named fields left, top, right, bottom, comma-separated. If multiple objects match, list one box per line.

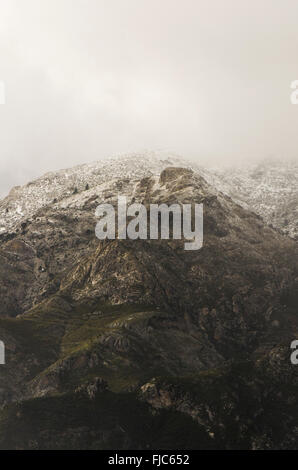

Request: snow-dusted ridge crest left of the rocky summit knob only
left=0, top=151, right=201, bottom=233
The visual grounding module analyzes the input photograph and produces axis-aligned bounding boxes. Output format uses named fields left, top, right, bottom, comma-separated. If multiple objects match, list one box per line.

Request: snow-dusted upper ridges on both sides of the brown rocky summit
left=0, top=151, right=298, bottom=237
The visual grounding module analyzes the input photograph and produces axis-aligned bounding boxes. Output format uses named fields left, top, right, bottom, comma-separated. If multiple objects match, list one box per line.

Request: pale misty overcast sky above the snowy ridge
left=0, top=0, right=298, bottom=196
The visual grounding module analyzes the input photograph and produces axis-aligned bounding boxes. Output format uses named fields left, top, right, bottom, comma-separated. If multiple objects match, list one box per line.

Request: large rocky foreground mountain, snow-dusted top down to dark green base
left=0, top=154, right=298, bottom=449
